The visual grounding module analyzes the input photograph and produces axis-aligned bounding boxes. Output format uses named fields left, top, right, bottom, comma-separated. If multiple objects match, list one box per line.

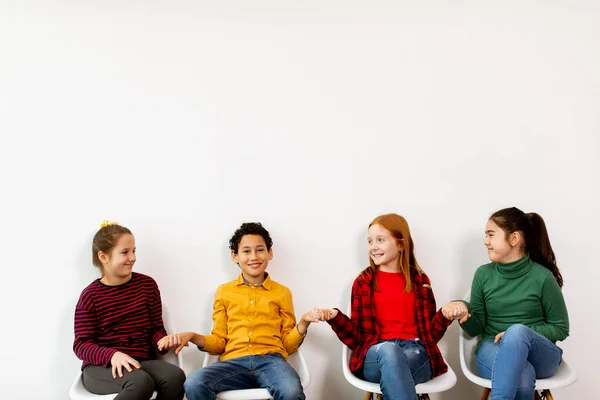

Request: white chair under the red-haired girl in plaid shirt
left=342, top=306, right=456, bottom=400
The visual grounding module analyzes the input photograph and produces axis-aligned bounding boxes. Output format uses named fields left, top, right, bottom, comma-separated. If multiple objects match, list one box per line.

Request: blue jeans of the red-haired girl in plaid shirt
left=363, top=339, right=431, bottom=400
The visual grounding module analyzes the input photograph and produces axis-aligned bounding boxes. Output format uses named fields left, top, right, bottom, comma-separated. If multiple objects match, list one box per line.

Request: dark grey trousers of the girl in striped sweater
left=83, top=360, right=185, bottom=400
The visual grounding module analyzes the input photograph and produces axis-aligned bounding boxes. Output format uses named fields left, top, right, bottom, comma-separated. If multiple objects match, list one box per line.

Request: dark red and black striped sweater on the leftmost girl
left=73, top=272, right=167, bottom=368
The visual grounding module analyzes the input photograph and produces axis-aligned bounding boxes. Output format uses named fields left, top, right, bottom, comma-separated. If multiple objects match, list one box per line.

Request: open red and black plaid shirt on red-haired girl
left=328, top=268, right=452, bottom=377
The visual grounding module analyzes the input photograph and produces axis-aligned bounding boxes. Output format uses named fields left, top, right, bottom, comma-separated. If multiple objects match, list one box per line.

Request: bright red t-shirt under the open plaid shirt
left=373, top=270, right=418, bottom=340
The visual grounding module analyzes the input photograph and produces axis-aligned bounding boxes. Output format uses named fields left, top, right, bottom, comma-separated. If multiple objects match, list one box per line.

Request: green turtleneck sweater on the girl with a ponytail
left=461, top=255, right=569, bottom=350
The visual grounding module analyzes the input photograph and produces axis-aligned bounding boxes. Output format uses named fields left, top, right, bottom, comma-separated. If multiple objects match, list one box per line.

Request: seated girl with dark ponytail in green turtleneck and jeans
left=442, top=207, right=569, bottom=400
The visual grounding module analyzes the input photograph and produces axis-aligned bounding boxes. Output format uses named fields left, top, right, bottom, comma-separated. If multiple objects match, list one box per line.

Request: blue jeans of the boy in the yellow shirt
left=183, top=353, right=305, bottom=400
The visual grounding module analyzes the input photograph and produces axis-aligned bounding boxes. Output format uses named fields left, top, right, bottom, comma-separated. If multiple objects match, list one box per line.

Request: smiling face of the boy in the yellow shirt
left=231, top=235, right=273, bottom=285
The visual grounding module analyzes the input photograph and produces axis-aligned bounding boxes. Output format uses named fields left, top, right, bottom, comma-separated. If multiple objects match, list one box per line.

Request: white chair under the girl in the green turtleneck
left=458, top=291, right=577, bottom=400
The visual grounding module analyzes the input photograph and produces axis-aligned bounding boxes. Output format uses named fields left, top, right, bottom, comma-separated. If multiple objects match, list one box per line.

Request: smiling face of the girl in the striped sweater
left=98, top=234, right=136, bottom=285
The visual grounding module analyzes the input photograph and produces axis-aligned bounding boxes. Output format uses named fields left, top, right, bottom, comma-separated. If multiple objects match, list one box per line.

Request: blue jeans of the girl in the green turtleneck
left=477, top=324, right=562, bottom=400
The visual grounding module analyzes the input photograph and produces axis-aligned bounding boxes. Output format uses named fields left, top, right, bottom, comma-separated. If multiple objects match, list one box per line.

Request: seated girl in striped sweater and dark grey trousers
left=73, top=221, right=185, bottom=400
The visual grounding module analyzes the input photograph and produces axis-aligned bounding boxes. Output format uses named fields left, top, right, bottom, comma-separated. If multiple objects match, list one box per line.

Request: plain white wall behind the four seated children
left=0, top=0, right=600, bottom=400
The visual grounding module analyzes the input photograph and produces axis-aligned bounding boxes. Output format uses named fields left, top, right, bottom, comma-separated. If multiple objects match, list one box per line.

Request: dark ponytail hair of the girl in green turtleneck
left=490, top=207, right=563, bottom=287
